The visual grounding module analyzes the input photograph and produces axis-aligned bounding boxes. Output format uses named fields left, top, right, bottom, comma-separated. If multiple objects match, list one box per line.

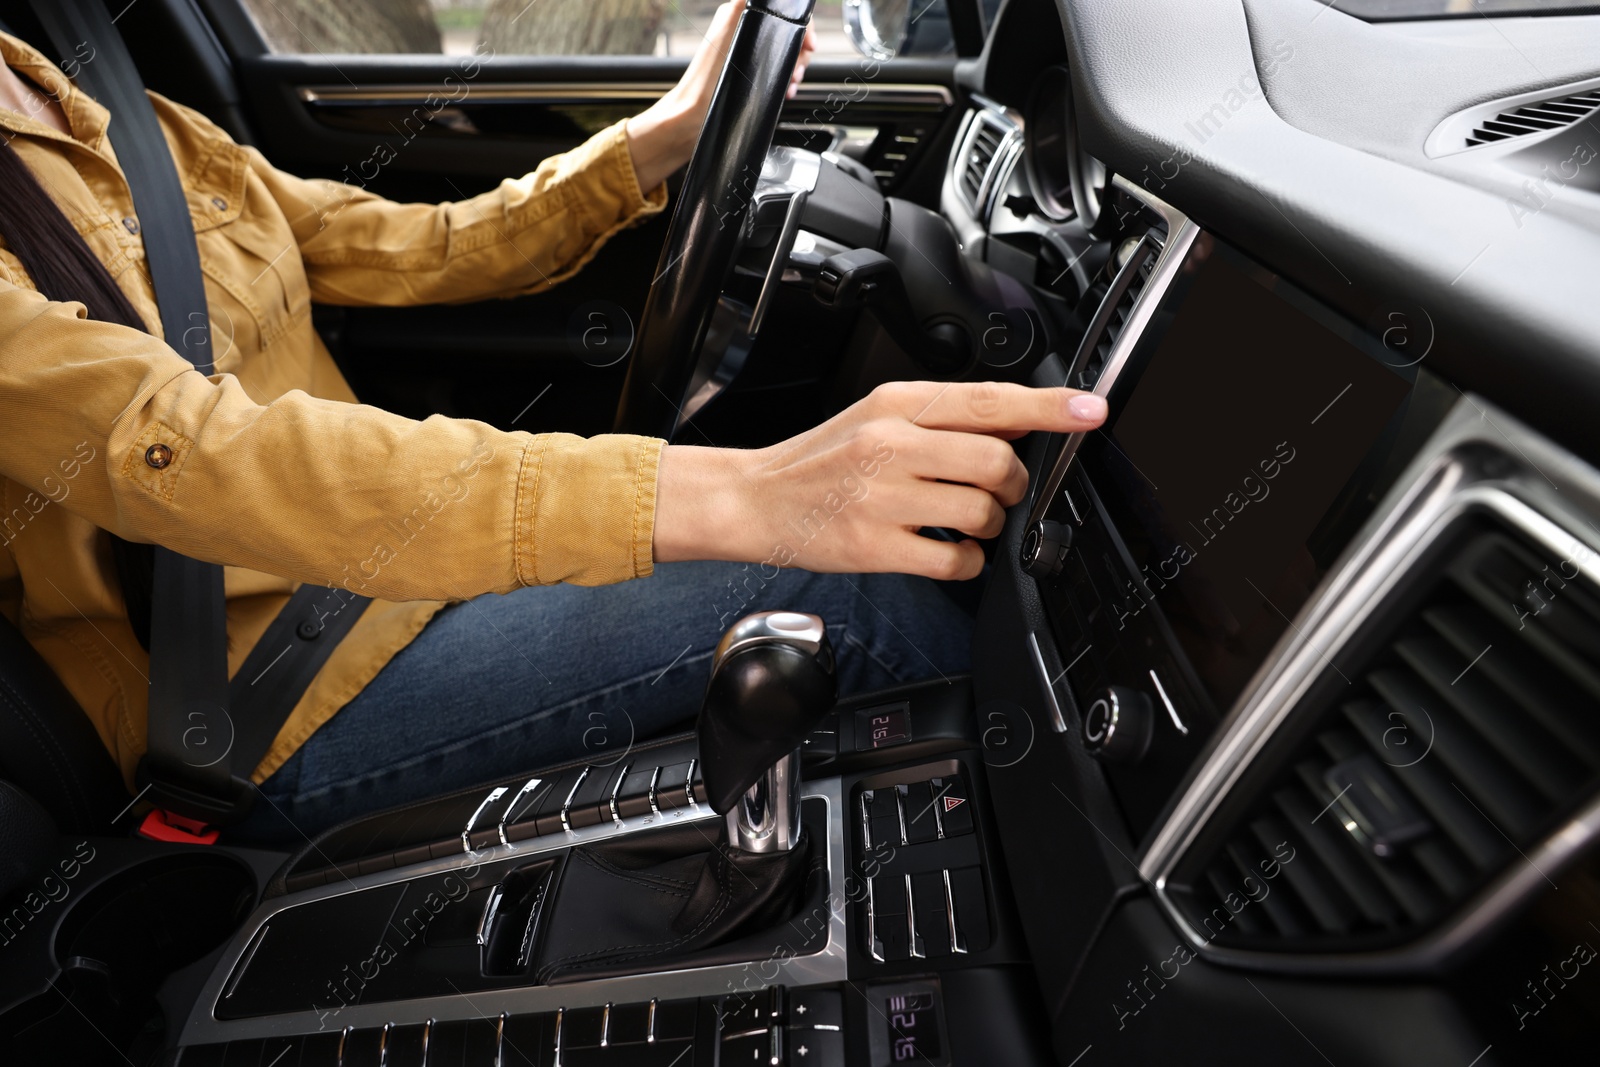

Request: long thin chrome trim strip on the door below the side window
left=298, top=82, right=955, bottom=107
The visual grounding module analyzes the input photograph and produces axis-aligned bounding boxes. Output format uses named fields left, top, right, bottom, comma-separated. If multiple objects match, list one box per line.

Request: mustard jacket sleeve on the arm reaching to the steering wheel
left=248, top=122, right=667, bottom=306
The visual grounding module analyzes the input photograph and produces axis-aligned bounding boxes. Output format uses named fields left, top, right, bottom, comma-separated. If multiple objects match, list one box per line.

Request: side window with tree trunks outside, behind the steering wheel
left=232, top=0, right=921, bottom=58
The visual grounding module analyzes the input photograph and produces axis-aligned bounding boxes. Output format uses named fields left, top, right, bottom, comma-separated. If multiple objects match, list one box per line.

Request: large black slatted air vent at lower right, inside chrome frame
left=1170, top=525, right=1600, bottom=952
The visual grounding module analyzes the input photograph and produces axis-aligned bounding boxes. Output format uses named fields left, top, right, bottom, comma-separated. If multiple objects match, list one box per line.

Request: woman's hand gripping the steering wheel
left=627, top=0, right=816, bottom=192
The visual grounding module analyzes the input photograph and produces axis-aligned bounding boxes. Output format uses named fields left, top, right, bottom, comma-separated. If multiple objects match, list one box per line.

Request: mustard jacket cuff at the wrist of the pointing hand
left=517, top=434, right=666, bottom=585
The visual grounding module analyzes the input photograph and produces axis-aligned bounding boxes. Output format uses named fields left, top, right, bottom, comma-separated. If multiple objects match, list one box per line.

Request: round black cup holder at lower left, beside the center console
left=56, top=853, right=256, bottom=985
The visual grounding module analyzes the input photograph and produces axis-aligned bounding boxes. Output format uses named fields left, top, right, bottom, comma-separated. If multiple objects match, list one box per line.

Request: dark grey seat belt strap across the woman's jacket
left=32, top=0, right=370, bottom=838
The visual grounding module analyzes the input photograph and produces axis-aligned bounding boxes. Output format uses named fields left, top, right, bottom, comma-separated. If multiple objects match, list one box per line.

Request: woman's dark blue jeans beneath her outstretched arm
left=229, top=563, right=971, bottom=846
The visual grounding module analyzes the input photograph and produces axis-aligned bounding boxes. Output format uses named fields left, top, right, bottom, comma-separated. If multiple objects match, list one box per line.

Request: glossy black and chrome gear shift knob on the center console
left=696, top=611, right=837, bottom=853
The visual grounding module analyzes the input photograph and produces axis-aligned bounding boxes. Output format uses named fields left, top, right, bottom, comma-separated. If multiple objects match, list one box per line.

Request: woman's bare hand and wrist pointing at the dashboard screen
left=654, top=382, right=1106, bottom=579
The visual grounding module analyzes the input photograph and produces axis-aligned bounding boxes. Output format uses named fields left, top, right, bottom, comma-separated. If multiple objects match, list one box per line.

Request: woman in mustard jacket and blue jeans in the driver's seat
left=0, top=5, right=1104, bottom=840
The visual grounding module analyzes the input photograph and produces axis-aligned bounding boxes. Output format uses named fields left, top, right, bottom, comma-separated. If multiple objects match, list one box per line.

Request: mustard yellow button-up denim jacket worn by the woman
left=0, top=34, right=666, bottom=782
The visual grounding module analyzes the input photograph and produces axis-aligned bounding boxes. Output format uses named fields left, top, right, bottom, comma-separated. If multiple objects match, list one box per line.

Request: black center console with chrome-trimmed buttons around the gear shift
left=168, top=641, right=1046, bottom=1067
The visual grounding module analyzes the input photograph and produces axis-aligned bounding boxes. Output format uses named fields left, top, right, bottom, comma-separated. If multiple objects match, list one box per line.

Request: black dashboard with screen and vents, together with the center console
left=46, top=0, right=1600, bottom=1067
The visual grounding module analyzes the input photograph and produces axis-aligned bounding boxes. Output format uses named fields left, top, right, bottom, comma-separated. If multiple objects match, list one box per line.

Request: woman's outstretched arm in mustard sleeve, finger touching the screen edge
left=0, top=280, right=1106, bottom=600
